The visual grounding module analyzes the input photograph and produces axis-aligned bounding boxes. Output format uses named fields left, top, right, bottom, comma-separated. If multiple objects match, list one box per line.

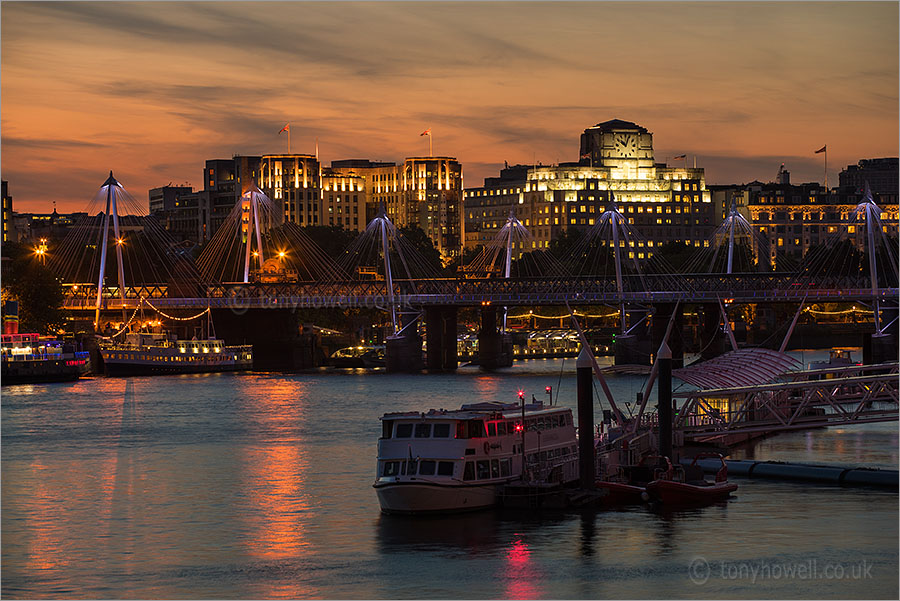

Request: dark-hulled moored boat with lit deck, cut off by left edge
left=0, top=334, right=91, bottom=385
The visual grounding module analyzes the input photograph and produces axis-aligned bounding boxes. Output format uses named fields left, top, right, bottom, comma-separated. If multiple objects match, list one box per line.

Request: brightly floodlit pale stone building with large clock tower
left=465, top=119, right=721, bottom=260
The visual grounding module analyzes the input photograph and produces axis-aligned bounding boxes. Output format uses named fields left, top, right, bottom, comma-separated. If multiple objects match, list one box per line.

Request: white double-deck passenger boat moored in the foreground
left=374, top=402, right=579, bottom=513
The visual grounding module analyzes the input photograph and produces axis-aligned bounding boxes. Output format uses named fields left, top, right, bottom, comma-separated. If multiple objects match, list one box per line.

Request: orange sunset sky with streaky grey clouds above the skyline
left=0, top=2, right=898, bottom=212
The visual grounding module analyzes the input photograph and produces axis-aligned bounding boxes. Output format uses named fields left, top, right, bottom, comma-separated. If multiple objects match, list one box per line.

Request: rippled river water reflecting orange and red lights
left=0, top=353, right=898, bottom=599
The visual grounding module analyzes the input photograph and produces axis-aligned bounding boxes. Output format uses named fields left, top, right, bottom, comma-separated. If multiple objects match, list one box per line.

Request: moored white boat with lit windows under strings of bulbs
left=100, top=332, right=253, bottom=376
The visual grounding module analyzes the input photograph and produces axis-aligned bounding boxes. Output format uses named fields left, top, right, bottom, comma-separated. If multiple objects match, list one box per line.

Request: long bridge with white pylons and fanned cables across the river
left=51, top=173, right=898, bottom=369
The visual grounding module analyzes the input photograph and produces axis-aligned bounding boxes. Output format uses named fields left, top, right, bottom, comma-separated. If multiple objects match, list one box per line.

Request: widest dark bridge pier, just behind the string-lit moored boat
left=213, top=309, right=325, bottom=371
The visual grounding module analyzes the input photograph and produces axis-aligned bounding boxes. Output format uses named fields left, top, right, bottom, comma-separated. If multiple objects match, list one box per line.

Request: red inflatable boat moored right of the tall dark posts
left=647, top=453, right=737, bottom=505
